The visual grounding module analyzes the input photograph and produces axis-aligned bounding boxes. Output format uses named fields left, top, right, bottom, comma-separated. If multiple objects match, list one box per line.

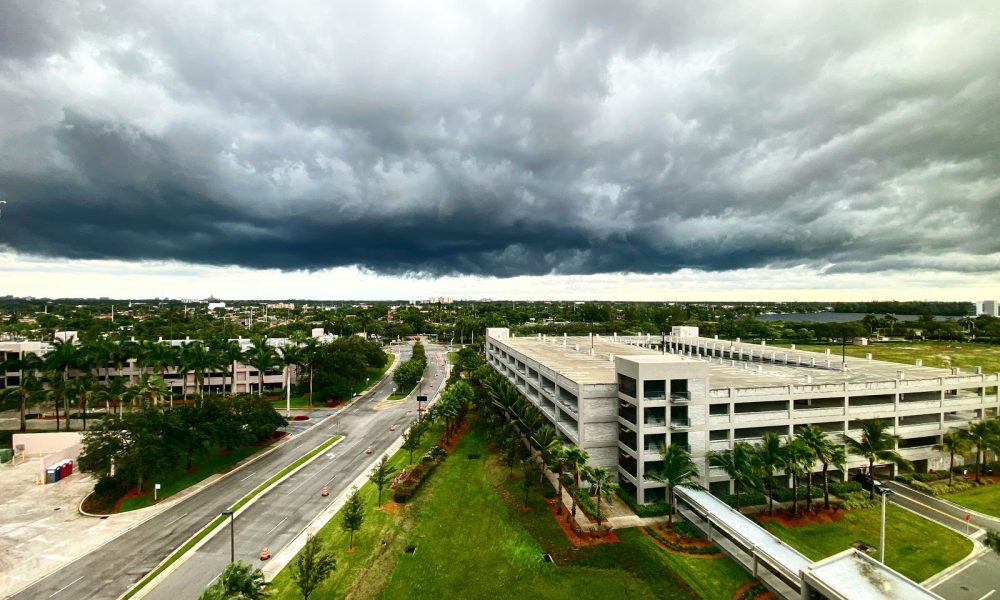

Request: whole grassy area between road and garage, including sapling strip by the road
left=272, top=428, right=751, bottom=600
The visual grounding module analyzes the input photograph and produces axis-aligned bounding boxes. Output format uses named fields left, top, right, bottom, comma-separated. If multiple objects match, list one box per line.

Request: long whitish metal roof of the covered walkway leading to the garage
left=674, top=486, right=941, bottom=600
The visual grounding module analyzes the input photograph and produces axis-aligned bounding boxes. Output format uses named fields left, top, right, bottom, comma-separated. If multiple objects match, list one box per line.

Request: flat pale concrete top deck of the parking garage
left=497, top=336, right=996, bottom=390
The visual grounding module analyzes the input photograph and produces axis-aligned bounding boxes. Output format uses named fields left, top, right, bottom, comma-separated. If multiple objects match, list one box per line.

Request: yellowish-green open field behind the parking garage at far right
left=795, top=342, right=1000, bottom=373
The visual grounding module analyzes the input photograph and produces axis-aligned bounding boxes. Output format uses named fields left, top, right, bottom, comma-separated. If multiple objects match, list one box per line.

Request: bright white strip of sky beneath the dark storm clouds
left=0, top=252, right=1000, bottom=302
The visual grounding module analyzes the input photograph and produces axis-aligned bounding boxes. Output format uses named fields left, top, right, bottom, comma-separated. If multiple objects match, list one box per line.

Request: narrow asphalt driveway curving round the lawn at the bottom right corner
left=885, top=481, right=1000, bottom=600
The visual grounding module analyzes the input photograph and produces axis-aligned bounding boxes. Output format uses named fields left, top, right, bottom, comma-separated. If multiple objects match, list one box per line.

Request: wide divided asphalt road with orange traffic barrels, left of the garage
left=13, top=345, right=447, bottom=600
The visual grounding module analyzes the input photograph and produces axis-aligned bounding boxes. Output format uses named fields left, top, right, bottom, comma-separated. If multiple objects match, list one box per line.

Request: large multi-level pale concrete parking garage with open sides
left=486, top=327, right=1000, bottom=503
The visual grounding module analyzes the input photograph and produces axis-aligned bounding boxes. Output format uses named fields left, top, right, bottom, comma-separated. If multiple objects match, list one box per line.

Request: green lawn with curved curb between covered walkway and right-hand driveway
left=766, top=505, right=972, bottom=582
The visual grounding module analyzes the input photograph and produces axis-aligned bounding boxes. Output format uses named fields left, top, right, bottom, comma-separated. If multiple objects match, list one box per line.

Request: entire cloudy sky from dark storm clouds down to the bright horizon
left=0, top=0, right=1000, bottom=300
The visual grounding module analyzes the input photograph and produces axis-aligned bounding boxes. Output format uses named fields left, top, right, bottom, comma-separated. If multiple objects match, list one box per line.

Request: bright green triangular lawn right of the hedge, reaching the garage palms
left=378, top=428, right=750, bottom=600
